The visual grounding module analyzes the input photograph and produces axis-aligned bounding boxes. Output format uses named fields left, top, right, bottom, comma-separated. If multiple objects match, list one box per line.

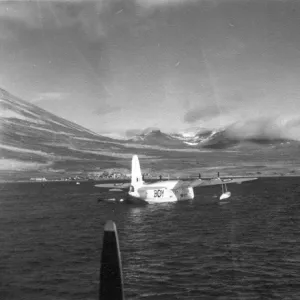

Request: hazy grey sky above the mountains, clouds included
left=0, top=0, right=300, bottom=135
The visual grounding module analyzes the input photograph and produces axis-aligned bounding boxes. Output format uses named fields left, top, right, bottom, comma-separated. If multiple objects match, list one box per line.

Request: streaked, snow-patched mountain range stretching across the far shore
left=0, top=89, right=300, bottom=179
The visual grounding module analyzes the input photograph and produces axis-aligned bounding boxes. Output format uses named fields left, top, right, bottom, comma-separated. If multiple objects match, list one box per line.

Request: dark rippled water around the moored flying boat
left=0, top=178, right=300, bottom=300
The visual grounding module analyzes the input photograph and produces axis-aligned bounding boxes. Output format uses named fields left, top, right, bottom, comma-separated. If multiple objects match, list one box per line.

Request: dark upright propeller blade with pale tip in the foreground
left=99, top=221, right=125, bottom=300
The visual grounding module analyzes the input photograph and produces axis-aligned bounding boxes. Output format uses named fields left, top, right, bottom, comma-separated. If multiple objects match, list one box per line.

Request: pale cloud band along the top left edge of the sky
left=0, top=0, right=234, bottom=42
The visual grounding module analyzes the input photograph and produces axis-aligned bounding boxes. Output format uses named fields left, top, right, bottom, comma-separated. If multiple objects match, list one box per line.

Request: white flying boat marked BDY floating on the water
left=95, top=155, right=257, bottom=203
